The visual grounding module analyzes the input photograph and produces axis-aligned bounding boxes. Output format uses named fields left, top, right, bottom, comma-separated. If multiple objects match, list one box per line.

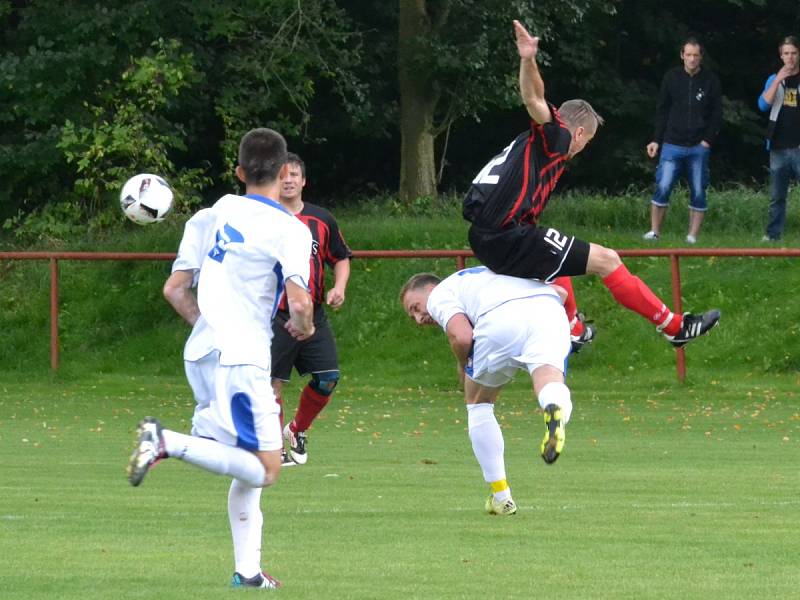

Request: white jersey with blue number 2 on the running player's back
left=198, top=194, right=311, bottom=371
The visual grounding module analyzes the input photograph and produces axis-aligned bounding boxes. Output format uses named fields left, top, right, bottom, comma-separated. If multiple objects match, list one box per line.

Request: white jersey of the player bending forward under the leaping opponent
left=427, top=267, right=561, bottom=329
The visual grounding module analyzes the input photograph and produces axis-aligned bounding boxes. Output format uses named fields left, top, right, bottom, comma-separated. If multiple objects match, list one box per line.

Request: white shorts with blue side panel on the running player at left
left=192, top=362, right=283, bottom=451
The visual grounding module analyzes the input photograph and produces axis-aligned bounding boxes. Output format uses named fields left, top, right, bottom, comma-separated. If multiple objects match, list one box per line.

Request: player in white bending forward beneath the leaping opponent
left=400, top=267, right=572, bottom=515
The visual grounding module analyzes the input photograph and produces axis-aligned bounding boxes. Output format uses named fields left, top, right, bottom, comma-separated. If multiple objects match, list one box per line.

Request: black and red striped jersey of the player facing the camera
left=278, top=202, right=353, bottom=310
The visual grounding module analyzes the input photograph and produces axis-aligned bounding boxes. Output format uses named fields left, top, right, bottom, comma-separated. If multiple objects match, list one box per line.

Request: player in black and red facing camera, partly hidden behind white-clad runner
left=272, top=152, right=353, bottom=464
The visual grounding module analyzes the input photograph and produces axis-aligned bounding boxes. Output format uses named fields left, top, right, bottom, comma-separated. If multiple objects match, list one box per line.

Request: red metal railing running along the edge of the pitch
left=0, top=248, right=800, bottom=383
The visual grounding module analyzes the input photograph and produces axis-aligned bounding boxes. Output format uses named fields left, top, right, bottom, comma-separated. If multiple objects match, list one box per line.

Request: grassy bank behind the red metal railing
left=0, top=188, right=800, bottom=376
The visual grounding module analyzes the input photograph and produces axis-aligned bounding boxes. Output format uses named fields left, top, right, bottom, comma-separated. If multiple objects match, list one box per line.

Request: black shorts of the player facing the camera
left=272, top=306, right=339, bottom=381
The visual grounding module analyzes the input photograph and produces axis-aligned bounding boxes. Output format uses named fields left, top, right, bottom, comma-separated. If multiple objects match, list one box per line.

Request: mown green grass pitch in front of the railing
left=0, top=366, right=800, bottom=600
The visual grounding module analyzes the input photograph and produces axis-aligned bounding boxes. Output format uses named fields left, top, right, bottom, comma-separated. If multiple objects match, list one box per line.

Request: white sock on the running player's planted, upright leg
left=228, top=479, right=264, bottom=579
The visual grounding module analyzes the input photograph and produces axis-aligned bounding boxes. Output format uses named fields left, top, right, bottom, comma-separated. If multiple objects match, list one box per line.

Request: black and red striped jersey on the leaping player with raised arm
left=463, top=105, right=572, bottom=228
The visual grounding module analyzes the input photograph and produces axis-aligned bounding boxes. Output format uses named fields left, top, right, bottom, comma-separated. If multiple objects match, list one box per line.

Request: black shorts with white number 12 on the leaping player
left=469, top=225, right=589, bottom=282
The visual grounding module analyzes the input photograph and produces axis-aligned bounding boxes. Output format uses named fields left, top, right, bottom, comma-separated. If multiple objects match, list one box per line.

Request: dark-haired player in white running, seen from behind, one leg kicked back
left=128, top=129, right=314, bottom=588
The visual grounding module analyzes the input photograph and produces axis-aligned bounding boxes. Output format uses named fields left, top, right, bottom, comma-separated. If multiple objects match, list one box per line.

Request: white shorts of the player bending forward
left=466, top=294, right=571, bottom=387
